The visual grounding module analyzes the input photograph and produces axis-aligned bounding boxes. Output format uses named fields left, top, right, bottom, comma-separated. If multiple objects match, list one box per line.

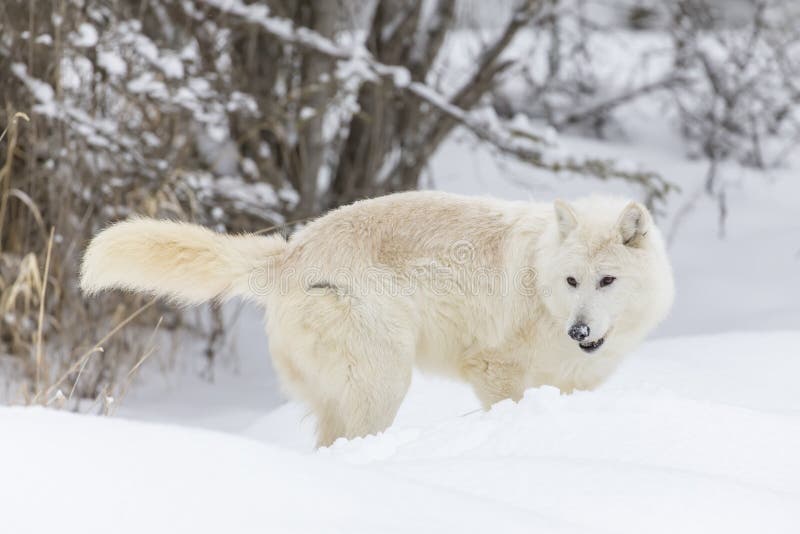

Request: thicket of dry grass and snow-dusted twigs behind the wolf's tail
left=0, top=0, right=247, bottom=412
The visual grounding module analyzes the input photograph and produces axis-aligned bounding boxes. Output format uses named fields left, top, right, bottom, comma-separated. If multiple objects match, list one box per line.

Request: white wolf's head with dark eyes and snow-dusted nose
left=536, top=197, right=674, bottom=360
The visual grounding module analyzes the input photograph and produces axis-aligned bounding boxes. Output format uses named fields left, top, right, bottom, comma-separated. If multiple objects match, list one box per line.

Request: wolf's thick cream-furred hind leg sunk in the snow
left=270, top=294, right=415, bottom=447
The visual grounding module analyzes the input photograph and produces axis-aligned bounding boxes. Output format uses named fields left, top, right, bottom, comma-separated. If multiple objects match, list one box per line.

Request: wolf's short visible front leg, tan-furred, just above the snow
left=462, top=353, right=526, bottom=409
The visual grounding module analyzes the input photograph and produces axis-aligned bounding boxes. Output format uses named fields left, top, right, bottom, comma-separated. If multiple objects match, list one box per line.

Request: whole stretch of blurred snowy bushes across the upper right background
left=495, top=0, right=800, bottom=230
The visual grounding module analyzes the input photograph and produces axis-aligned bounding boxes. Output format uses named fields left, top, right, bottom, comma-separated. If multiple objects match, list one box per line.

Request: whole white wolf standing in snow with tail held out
left=81, top=192, right=674, bottom=446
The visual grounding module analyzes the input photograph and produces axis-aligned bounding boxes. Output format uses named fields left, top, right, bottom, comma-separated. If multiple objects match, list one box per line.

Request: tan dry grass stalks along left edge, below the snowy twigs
left=0, top=107, right=181, bottom=413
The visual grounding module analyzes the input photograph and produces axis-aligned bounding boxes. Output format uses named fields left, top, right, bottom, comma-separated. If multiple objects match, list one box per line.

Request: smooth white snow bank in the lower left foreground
left=0, top=408, right=536, bottom=534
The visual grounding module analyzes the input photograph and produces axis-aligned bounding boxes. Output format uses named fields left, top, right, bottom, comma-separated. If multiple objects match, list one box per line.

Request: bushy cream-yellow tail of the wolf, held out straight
left=81, top=219, right=286, bottom=304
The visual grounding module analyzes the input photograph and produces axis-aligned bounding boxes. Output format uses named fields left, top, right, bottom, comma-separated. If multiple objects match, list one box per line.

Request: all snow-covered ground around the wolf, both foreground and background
left=0, top=31, right=800, bottom=534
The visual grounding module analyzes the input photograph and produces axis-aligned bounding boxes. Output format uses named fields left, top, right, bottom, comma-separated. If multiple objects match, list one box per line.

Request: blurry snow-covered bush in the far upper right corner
left=671, top=0, right=800, bottom=221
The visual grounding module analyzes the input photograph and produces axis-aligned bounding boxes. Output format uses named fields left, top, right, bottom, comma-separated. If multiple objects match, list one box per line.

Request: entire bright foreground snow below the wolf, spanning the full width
left=6, top=332, right=800, bottom=534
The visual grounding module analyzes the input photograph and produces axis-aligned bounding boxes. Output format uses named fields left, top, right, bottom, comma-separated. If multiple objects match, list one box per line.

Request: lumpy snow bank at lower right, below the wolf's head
left=326, top=388, right=800, bottom=534
